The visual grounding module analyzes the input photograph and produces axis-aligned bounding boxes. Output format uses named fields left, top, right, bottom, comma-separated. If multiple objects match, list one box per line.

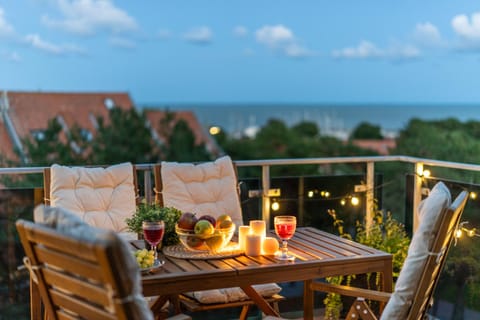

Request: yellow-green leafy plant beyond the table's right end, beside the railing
left=323, top=206, right=410, bottom=319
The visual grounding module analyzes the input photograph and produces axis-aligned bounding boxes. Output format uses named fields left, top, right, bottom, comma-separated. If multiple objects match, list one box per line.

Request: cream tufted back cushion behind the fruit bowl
left=162, top=156, right=243, bottom=226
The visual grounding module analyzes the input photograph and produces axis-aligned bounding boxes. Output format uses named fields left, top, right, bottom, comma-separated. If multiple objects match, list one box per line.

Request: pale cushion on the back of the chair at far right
left=380, top=182, right=451, bottom=319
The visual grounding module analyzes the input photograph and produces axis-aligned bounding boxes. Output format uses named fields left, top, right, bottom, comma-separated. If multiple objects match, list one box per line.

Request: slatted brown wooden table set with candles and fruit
left=142, top=227, right=392, bottom=319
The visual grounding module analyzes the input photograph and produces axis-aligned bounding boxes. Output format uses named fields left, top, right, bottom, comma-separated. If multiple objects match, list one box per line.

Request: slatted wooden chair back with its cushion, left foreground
left=16, top=205, right=153, bottom=320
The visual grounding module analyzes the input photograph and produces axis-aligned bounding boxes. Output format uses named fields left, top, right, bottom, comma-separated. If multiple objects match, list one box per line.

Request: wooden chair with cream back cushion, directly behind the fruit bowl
left=153, top=156, right=285, bottom=319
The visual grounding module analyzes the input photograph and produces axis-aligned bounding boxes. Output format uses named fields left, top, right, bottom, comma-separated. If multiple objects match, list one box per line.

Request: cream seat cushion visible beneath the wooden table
left=185, top=283, right=282, bottom=304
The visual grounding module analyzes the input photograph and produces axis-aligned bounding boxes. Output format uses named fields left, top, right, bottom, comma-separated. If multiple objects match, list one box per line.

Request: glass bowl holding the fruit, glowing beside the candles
left=175, top=224, right=235, bottom=252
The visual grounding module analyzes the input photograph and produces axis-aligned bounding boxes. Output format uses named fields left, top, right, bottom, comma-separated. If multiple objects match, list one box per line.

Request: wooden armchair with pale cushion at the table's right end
left=311, top=182, right=468, bottom=320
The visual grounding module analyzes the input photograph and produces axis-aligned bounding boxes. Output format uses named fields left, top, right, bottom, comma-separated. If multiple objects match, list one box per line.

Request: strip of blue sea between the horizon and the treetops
left=142, top=102, right=480, bottom=138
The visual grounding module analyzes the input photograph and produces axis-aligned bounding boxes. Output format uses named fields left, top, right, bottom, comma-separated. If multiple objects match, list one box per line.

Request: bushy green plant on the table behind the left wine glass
left=125, top=201, right=182, bottom=246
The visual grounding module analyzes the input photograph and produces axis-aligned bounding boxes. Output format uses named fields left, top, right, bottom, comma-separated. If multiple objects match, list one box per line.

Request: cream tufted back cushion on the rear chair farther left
left=50, top=163, right=136, bottom=232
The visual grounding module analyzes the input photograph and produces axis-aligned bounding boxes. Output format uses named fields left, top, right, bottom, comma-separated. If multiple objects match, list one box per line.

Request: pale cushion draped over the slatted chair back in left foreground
left=34, top=205, right=153, bottom=320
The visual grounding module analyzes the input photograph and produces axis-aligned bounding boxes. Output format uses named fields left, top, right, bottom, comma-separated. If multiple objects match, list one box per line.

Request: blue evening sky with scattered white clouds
left=0, top=0, right=480, bottom=105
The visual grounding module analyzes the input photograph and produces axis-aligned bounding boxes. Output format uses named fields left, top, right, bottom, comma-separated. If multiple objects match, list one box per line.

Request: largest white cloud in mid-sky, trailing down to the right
left=255, top=24, right=313, bottom=58
